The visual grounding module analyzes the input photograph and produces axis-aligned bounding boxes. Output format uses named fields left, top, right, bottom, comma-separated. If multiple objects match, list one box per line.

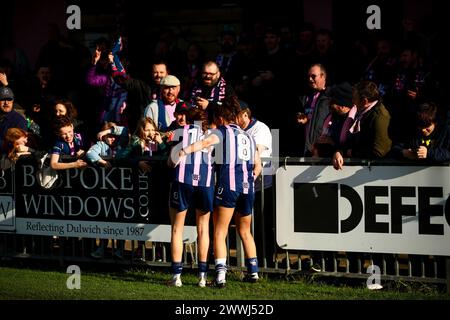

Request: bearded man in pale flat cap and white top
left=144, top=75, right=183, bottom=132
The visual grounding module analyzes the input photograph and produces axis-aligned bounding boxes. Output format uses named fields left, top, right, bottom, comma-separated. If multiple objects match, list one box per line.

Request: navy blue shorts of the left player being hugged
left=169, top=181, right=214, bottom=212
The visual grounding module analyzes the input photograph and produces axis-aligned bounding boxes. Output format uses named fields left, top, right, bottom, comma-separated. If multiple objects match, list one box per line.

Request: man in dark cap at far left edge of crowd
left=0, top=87, right=27, bottom=149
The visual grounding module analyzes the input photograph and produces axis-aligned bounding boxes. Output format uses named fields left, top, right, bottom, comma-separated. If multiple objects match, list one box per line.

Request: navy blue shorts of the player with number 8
left=214, top=187, right=255, bottom=216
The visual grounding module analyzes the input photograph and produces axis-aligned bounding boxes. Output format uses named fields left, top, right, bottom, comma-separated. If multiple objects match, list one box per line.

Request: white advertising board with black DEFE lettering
left=276, top=165, right=450, bottom=256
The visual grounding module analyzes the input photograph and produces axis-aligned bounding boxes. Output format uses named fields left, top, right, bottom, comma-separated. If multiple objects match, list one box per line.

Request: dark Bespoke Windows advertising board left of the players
left=0, top=158, right=197, bottom=242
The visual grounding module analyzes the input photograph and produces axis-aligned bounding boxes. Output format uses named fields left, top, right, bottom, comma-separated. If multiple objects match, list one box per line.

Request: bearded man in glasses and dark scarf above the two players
left=190, top=61, right=235, bottom=123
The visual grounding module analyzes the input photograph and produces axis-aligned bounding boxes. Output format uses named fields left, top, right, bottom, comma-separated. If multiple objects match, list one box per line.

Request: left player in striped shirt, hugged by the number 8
left=169, top=108, right=214, bottom=287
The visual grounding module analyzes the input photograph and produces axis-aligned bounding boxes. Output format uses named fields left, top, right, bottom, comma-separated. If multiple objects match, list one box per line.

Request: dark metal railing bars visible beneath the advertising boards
left=0, top=234, right=447, bottom=284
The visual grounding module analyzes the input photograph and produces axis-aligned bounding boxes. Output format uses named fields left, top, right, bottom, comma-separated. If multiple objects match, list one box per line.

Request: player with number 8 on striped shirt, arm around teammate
left=175, top=96, right=262, bottom=287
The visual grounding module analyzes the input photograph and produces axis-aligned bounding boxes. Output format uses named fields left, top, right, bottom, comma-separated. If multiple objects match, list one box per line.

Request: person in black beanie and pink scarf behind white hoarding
left=313, top=82, right=356, bottom=157
